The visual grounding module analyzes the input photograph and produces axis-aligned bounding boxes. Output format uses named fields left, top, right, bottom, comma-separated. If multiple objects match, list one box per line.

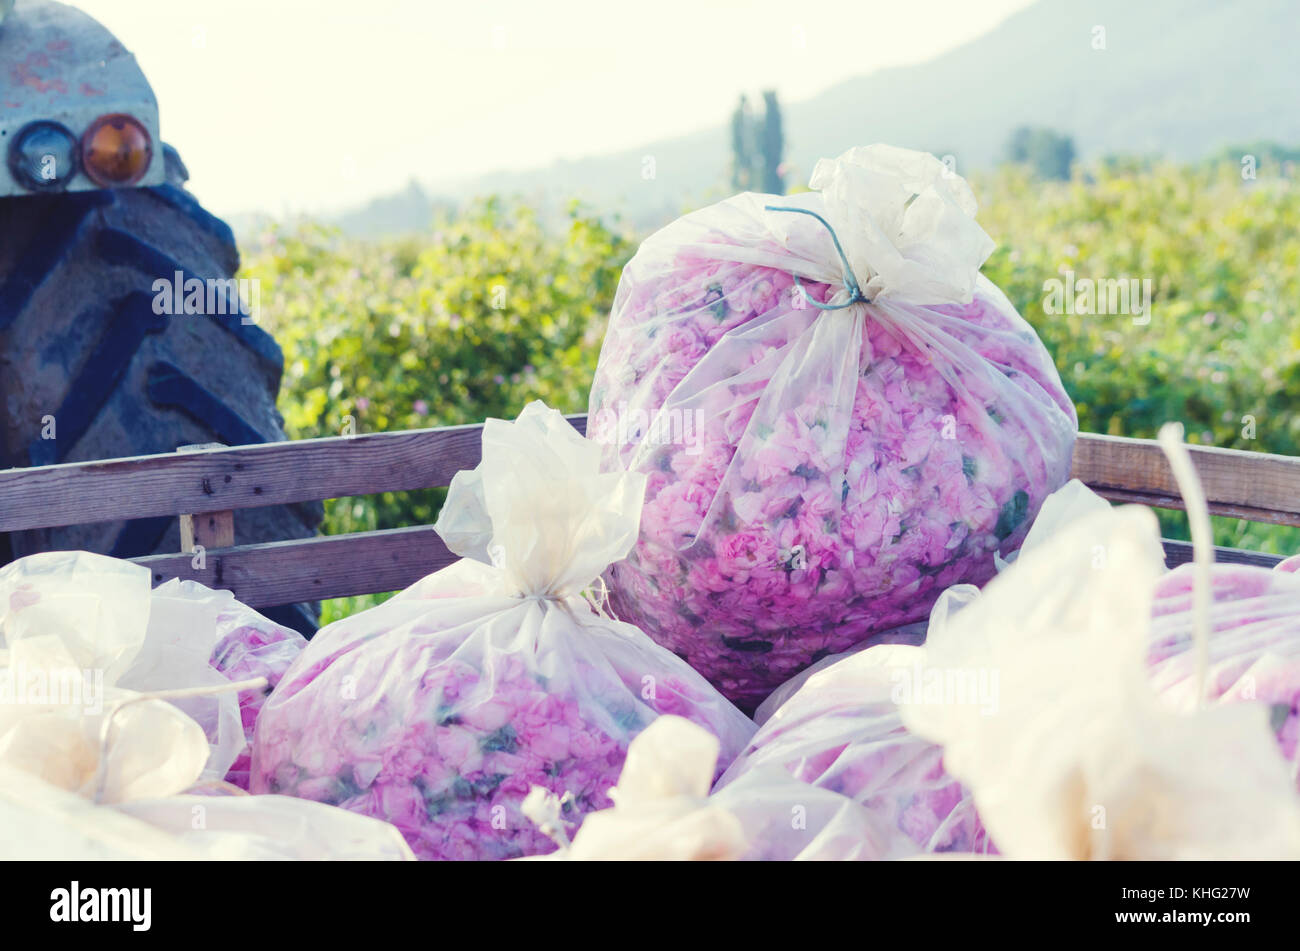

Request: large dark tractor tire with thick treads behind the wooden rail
left=0, top=147, right=321, bottom=635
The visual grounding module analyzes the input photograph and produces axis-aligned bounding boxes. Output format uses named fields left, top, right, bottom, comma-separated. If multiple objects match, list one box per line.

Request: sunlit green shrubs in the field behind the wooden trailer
left=244, top=162, right=1300, bottom=618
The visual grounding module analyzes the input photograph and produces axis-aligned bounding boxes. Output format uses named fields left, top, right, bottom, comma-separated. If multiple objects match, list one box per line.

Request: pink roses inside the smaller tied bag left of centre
left=252, top=631, right=754, bottom=860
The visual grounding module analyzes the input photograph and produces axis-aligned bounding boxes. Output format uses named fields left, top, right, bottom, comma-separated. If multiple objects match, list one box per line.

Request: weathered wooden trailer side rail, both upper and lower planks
left=0, top=416, right=1300, bottom=607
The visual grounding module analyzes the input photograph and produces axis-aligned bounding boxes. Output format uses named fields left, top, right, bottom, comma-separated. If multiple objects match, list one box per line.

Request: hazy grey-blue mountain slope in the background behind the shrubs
left=289, top=0, right=1300, bottom=235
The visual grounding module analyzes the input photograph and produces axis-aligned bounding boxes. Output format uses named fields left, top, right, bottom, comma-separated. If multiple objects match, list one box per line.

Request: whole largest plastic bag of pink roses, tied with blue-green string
left=589, top=146, right=1078, bottom=708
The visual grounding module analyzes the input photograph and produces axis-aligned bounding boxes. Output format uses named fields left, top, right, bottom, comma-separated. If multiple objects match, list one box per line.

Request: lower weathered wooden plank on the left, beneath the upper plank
left=133, top=525, right=456, bottom=608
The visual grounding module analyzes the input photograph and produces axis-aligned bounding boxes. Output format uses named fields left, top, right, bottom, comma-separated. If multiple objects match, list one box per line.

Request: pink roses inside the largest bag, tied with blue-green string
left=589, top=245, right=1076, bottom=708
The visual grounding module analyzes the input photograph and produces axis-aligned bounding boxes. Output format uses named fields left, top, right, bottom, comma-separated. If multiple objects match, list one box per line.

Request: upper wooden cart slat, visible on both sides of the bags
left=0, top=426, right=1300, bottom=531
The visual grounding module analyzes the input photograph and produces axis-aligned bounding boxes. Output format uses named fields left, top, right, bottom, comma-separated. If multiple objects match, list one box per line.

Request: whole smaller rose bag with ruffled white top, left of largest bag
left=251, top=403, right=754, bottom=859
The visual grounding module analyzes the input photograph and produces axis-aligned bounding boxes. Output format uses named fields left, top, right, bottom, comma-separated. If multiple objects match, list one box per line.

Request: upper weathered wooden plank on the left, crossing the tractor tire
left=0, top=416, right=586, bottom=531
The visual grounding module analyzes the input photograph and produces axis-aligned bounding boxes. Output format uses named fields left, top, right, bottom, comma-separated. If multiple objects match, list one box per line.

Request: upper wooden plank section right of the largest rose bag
left=1073, top=433, right=1300, bottom=525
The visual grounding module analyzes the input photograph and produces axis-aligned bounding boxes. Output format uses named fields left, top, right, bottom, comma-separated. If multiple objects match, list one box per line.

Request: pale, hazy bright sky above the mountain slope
left=74, top=0, right=1031, bottom=214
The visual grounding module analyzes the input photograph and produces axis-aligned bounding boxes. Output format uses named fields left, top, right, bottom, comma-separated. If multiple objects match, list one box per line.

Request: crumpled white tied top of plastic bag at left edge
left=0, top=552, right=244, bottom=802
